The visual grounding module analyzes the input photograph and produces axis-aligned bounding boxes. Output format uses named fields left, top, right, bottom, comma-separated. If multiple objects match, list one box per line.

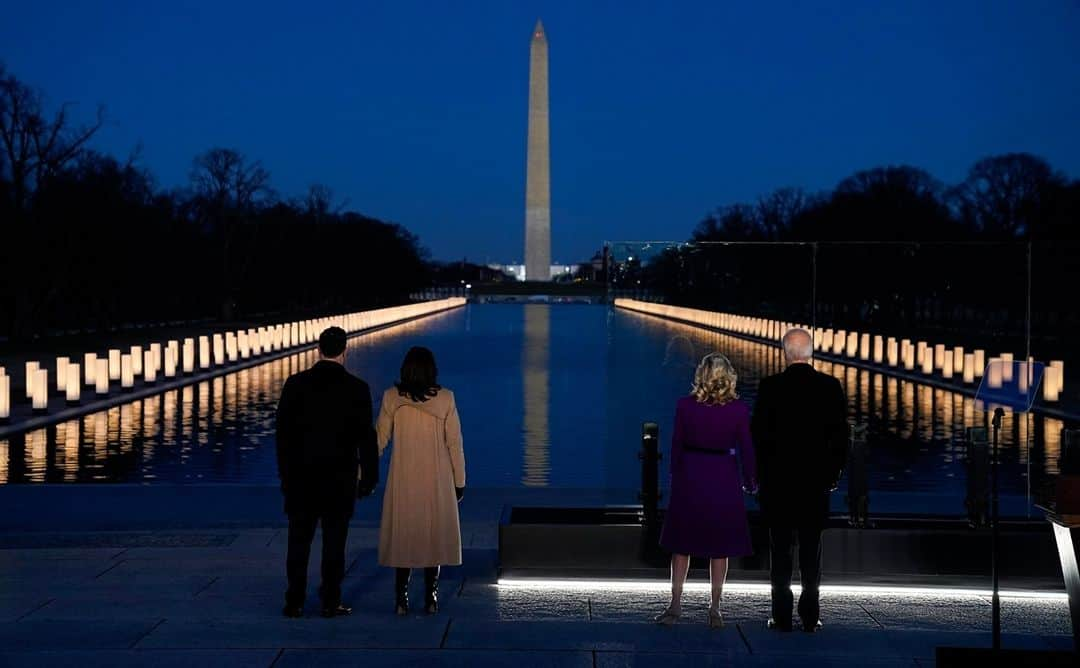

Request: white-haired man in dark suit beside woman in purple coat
left=751, top=329, right=848, bottom=632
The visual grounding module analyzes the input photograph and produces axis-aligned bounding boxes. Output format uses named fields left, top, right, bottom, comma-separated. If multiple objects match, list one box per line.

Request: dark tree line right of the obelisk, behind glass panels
left=630, top=161, right=1080, bottom=355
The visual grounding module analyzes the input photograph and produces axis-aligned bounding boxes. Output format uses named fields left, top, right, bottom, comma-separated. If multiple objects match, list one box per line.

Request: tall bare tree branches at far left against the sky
left=0, top=64, right=105, bottom=213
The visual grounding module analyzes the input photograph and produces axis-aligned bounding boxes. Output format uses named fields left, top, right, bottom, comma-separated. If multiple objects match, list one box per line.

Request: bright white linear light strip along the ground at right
left=497, top=577, right=1068, bottom=601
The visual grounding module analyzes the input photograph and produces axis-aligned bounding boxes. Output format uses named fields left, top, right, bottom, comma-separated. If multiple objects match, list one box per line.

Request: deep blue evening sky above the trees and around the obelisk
left=0, top=0, right=1080, bottom=261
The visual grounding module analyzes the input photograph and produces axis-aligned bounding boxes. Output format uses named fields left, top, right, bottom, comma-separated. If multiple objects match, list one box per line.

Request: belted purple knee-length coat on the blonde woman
left=660, top=396, right=757, bottom=559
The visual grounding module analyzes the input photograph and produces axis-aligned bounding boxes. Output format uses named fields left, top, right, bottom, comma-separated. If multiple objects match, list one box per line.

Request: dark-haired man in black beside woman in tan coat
left=278, top=327, right=379, bottom=617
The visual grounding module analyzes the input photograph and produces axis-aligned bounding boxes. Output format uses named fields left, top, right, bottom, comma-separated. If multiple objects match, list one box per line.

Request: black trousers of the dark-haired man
left=285, top=514, right=349, bottom=608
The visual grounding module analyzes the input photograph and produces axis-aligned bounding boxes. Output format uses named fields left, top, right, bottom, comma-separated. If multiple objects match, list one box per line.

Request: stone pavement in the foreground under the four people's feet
left=0, top=521, right=1071, bottom=668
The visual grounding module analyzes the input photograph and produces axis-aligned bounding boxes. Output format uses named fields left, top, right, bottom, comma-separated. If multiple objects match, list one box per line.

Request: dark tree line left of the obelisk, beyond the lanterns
left=0, top=65, right=431, bottom=339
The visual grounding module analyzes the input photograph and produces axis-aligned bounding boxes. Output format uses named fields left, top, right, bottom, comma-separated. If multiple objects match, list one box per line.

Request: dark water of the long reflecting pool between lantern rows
left=0, top=304, right=1063, bottom=513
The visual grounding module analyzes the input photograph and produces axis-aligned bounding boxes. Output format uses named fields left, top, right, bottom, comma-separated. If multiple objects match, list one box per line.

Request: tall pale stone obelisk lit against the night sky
left=525, top=21, right=551, bottom=281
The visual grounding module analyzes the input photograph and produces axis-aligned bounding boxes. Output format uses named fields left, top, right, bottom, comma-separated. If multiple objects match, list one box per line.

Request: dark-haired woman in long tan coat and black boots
left=375, top=347, right=465, bottom=615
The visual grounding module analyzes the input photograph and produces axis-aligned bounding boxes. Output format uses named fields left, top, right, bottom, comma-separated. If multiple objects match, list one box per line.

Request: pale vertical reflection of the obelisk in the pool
left=522, top=304, right=551, bottom=487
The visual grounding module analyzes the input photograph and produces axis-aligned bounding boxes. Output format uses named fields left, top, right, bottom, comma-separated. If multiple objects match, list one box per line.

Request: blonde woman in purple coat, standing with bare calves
left=656, top=353, right=757, bottom=628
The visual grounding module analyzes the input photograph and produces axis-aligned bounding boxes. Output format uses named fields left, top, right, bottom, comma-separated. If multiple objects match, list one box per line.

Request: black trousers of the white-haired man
left=769, top=527, right=822, bottom=626
